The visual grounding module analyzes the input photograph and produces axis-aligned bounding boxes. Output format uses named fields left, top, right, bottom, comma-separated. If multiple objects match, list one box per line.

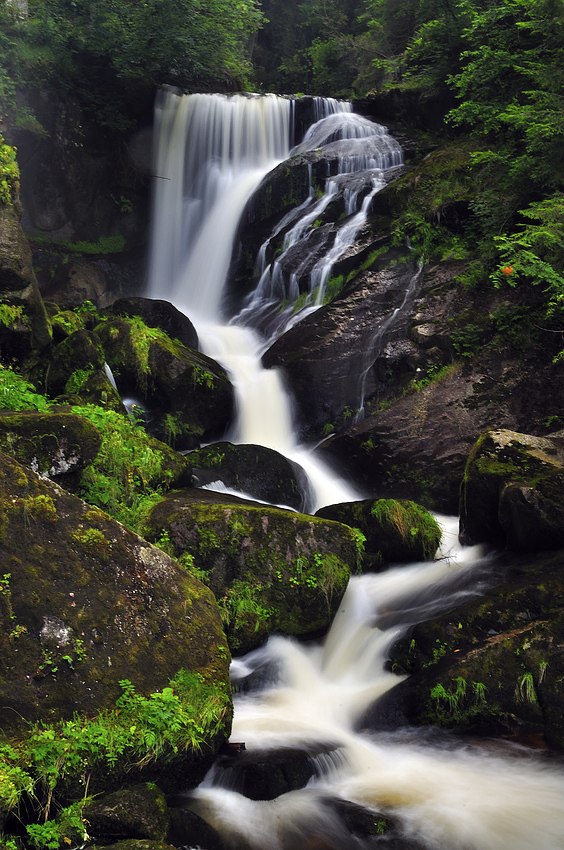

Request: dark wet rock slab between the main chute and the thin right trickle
left=263, top=265, right=419, bottom=439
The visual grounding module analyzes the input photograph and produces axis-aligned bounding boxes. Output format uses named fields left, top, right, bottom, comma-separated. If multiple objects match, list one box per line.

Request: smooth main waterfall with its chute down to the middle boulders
left=149, top=90, right=357, bottom=510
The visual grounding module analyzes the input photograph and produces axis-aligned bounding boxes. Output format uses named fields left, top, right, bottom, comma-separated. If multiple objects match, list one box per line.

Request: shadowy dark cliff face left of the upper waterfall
left=5, top=88, right=149, bottom=249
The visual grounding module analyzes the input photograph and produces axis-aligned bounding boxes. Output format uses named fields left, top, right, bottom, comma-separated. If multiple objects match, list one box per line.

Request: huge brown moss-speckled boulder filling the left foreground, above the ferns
left=0, top=455, right=229, bottom=748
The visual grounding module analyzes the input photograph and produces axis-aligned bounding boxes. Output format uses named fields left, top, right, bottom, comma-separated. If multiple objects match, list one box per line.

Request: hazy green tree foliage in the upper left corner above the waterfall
left=0, top=0, right=262, bottom=132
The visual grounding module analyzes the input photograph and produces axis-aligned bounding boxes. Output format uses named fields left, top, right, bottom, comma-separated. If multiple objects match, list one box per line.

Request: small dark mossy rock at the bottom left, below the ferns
left=82, top=783, right=169, bottom=842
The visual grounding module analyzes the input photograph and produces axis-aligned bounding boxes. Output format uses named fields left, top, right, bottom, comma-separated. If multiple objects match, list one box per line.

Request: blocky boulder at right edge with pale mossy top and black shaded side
left=460, top=429, right=564, bottom=552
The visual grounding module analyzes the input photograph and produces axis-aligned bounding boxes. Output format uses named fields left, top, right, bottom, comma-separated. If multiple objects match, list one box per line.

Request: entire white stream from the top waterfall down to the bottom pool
left=150, top=92, right=564, bottom=850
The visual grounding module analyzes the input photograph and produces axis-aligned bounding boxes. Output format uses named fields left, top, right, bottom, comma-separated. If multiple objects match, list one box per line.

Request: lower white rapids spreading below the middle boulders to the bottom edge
left=191, top=518, right=564, bottom=850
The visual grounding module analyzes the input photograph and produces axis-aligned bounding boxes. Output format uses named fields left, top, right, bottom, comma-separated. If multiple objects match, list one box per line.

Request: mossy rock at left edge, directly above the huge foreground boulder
left=0, top=411, right=102, bottom=485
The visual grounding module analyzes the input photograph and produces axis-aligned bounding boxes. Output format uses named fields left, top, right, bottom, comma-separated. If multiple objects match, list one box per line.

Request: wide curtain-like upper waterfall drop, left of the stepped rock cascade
left=149, top=89, right=291, bottom=321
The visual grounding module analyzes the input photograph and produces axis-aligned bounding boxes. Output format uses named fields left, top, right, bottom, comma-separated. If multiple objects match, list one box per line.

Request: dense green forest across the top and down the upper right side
left=0, top=0, right=564, bottom=344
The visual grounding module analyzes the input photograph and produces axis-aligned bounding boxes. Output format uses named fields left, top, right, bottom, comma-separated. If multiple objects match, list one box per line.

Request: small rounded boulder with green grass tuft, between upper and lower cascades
left=316, top=499, right=441, bottom=570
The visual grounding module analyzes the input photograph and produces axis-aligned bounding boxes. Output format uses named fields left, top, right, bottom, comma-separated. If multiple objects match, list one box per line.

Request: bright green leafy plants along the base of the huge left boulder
left=0, top=670, right=229, bottom=850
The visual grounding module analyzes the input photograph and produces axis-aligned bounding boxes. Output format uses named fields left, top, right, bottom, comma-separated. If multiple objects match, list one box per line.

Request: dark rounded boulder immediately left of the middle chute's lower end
left=190, top=442, right=308, bottom=511
